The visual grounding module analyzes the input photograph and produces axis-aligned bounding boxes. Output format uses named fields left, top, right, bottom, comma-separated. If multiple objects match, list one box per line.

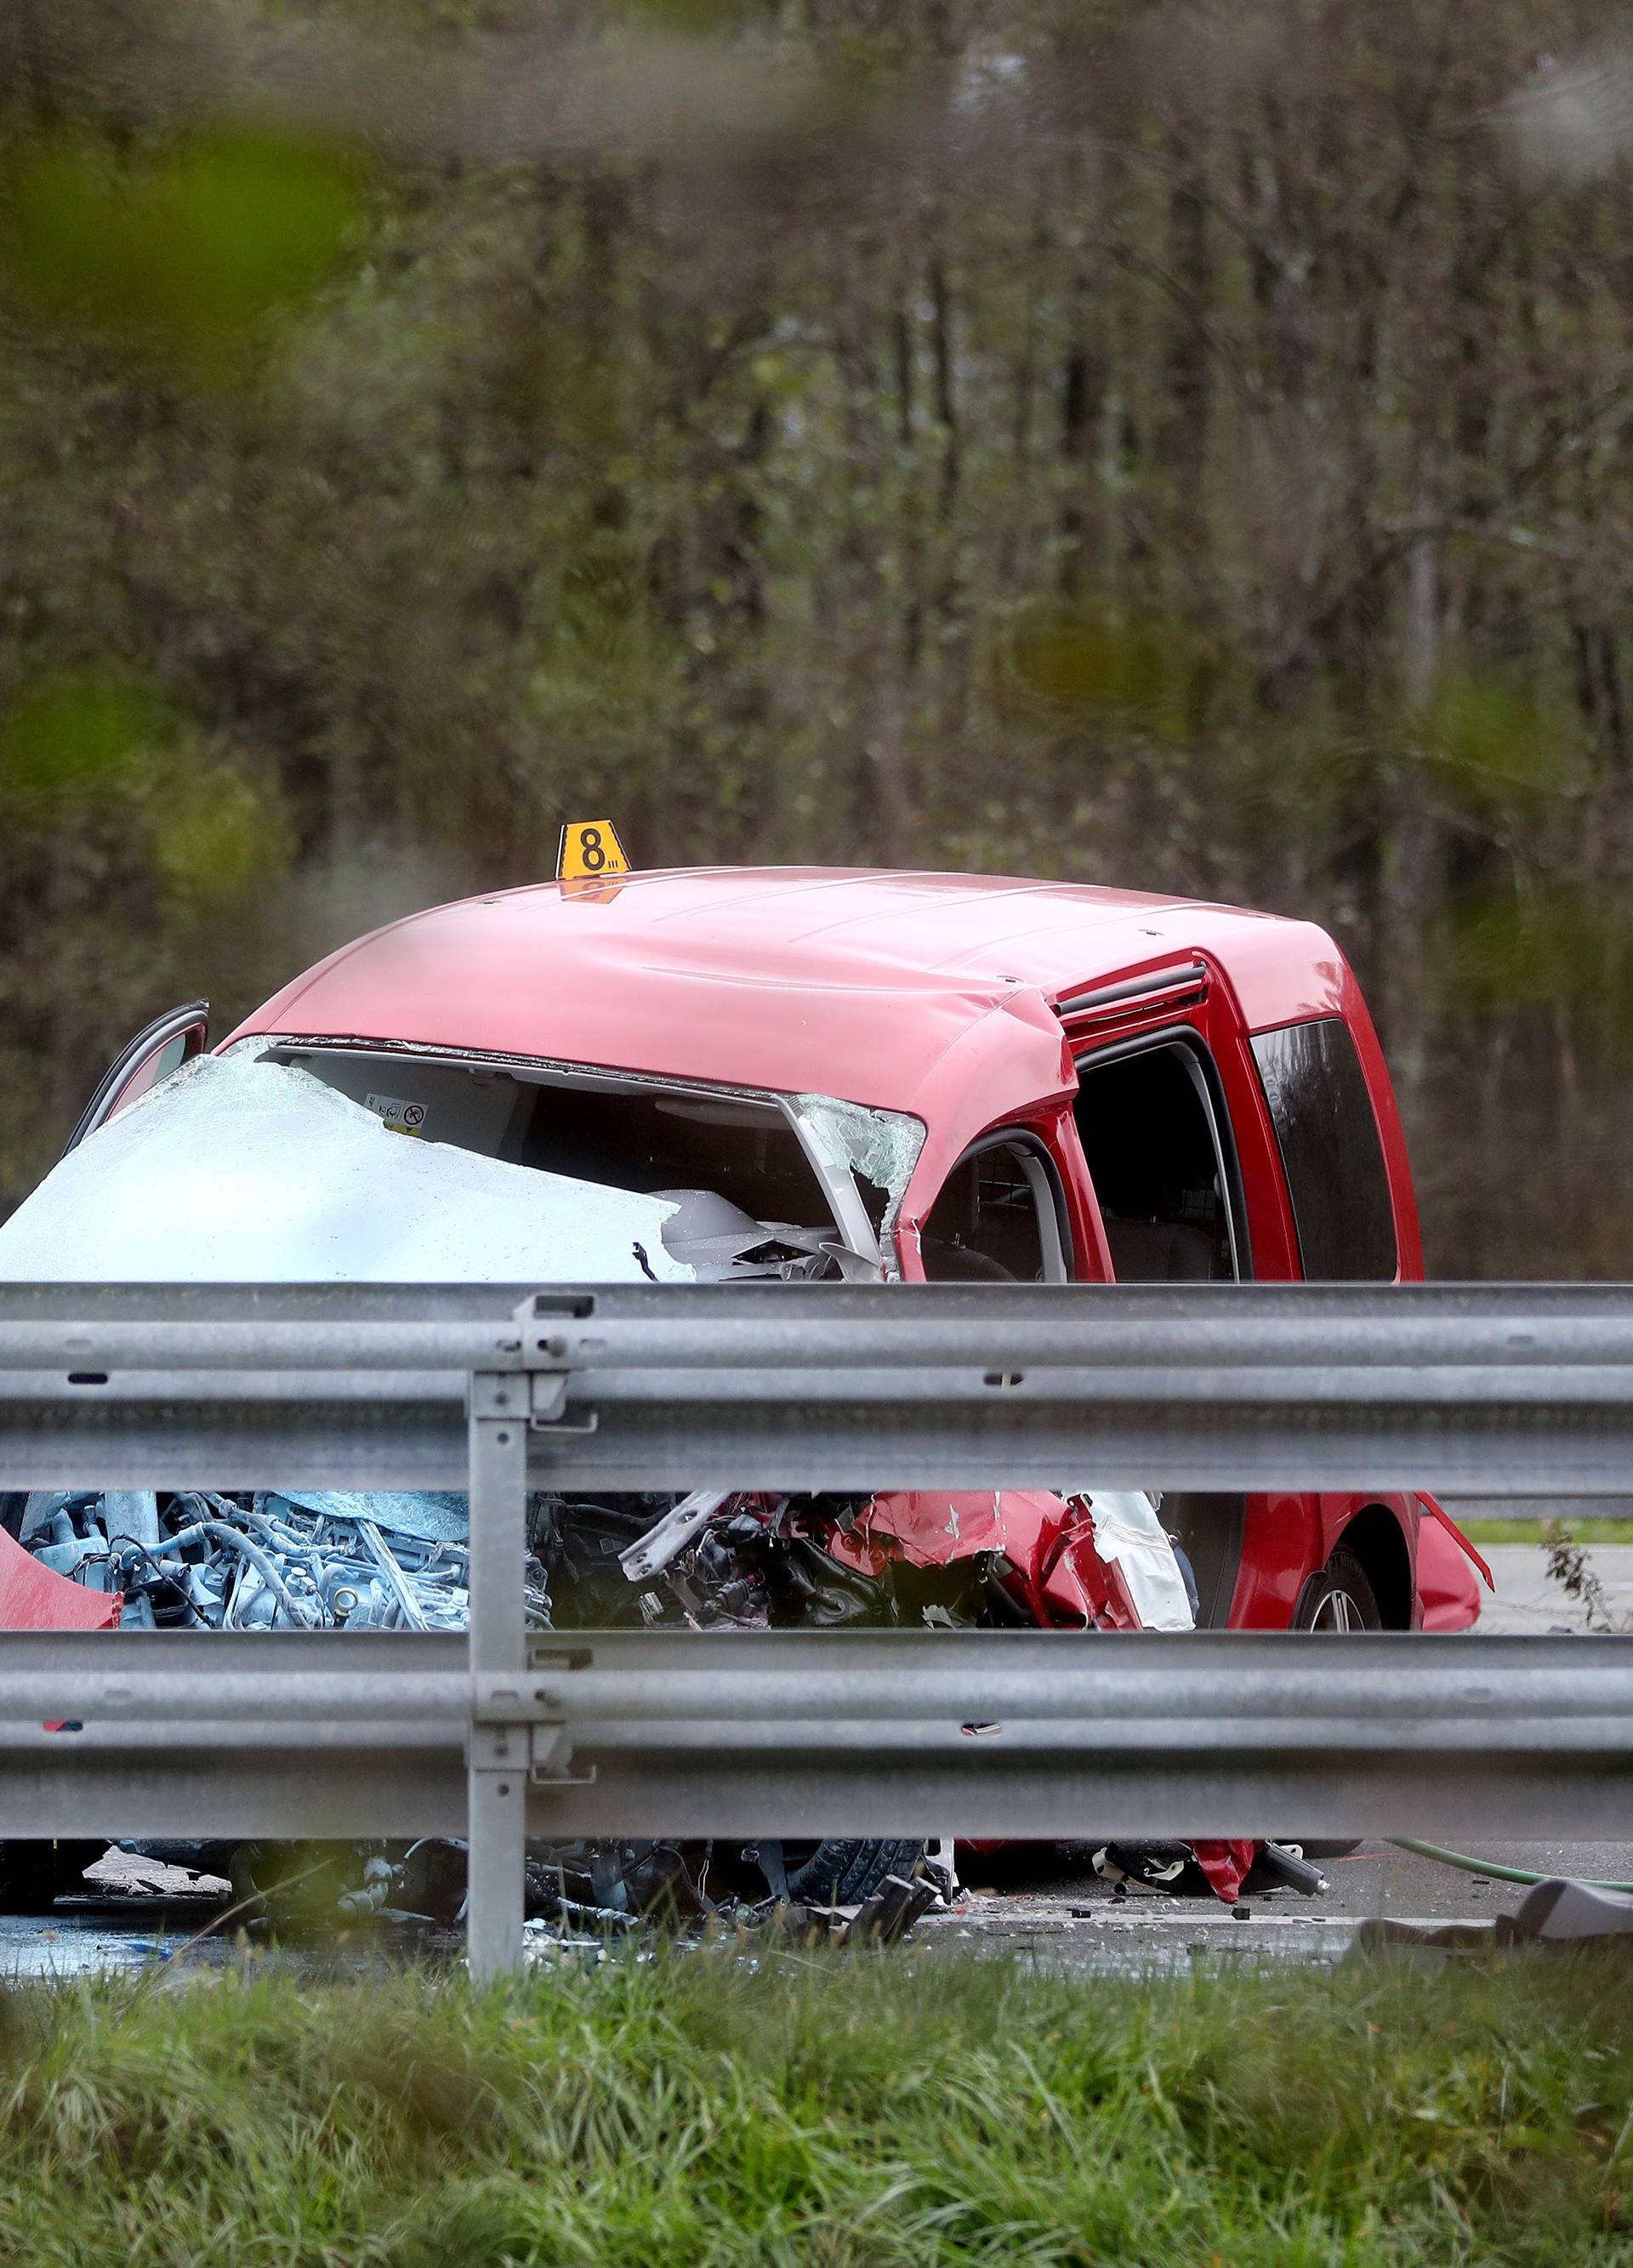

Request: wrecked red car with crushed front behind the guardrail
left=0, top=868, right=1479, bottom=1913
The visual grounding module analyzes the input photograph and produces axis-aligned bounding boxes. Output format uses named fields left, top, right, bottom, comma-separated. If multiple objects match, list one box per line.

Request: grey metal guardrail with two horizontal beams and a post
left=0, top=1286, right=1633, bottom=1978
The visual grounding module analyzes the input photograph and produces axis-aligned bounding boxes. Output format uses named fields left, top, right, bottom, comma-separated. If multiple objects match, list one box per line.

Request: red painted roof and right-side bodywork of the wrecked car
left=191, top=868, right=1451, bottom=1629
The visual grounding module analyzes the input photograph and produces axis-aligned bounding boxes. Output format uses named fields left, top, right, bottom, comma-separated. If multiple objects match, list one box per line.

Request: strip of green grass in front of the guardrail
left=0, top=1953, right=1633, bottom=2268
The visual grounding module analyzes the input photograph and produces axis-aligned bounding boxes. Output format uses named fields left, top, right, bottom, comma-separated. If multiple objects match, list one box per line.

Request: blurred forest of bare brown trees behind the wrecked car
left=0, top=0, right=1633, bottom=1277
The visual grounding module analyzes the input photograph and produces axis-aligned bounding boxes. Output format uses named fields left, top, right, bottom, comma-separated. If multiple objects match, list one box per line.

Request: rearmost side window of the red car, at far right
left=1252, top=1016, right=1399, bottom=1284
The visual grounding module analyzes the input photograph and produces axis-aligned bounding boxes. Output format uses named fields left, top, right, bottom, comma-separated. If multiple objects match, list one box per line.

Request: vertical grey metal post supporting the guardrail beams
left=465, top=1370, right=531, bottom=1987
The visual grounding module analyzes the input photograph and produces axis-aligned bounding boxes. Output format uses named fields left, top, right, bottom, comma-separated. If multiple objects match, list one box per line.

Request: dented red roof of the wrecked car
left=234, top=867, right=1351, bottom=1118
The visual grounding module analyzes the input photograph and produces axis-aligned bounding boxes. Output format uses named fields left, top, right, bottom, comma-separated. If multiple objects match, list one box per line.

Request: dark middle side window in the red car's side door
left=1075, top=1038, right=1248, bottom=1284
